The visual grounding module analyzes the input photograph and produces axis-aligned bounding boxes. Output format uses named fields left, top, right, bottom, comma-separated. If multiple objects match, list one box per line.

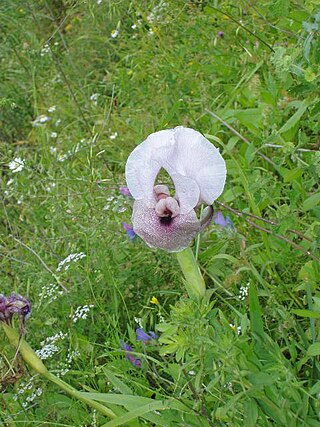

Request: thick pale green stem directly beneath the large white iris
left=177, top=248, right=206, bottom=299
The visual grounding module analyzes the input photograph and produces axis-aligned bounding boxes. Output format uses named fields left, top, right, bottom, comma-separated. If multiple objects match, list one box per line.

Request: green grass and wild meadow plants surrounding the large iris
left=0, top=0, right=320, bottom=427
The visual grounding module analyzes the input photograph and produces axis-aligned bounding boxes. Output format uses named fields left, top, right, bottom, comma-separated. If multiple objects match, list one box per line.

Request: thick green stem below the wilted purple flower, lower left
left=2, top=323, right=116, bottom=418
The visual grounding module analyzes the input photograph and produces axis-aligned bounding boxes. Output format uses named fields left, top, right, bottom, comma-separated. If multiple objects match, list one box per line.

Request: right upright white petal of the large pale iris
left=164, top=126, right=227, bottom=205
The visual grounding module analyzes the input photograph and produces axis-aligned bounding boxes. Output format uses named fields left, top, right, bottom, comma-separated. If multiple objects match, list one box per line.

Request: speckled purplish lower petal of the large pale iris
left=132, top=200, right=202, bottom=252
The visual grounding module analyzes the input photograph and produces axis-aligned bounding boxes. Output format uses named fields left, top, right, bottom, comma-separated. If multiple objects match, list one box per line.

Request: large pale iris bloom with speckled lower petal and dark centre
left=126, top=126, right=226, bottom=252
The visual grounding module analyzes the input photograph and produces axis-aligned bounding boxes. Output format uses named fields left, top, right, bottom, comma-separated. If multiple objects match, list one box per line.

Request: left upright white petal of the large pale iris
left=126, top=129, right=174, bottom=201
